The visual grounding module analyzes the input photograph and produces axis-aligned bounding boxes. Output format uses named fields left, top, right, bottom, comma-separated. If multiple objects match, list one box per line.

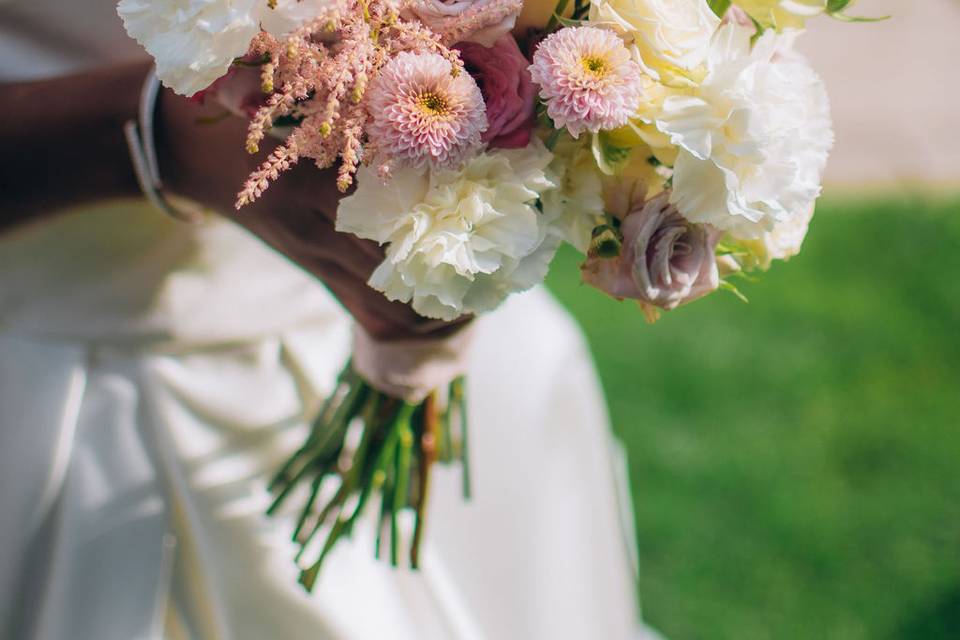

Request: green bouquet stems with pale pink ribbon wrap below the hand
left=268, top=327, right=472, bottom=591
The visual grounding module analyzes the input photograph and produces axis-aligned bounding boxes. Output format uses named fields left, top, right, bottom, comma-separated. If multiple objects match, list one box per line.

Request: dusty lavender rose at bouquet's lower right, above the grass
left=581, top=192, right=720, bottom=310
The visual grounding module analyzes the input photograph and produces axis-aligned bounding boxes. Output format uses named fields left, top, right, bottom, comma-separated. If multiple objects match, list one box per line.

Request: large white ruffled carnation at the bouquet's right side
left=656, top=24, right=833, bottom=238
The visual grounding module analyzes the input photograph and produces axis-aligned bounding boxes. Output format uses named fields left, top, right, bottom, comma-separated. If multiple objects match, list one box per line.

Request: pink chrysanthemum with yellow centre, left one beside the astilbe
left=367, top=51, right=487, bottom=168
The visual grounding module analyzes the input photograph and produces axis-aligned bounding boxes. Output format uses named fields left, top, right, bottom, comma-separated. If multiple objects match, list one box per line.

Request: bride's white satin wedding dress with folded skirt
left=0, top=0, right=643, bottom=640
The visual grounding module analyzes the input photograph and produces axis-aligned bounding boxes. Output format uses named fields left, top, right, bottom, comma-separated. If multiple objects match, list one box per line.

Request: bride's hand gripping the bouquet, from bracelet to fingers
left=157, top=75, right=468, bottom=340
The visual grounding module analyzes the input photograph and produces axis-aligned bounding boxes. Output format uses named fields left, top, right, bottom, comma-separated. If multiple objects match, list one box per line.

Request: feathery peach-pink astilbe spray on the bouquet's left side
left=236, top=0, right=523, bottom=208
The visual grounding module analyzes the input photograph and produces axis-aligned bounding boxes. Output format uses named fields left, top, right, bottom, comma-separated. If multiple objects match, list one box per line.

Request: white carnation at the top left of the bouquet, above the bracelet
left=117, top=0, right=325, bottom=95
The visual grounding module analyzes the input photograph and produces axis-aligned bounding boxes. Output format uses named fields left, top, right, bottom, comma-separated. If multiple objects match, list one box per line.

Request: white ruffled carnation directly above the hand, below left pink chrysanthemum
left=337, top=141, right=560, bottom=320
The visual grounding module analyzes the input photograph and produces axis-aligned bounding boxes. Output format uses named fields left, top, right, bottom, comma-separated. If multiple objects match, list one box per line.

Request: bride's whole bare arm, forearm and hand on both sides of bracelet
left=0, top=63, right=469, bottom=340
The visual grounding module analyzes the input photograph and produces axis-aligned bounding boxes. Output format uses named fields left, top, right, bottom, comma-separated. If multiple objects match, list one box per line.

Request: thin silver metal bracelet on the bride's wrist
left=123, top=68, right=203, bottom=224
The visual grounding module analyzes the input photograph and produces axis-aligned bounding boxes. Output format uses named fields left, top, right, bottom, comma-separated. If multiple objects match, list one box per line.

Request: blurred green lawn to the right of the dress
left=548, top=197, right=960, bottom=640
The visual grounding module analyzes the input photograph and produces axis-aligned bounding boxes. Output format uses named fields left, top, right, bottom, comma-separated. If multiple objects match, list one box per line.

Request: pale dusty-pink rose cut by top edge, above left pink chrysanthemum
left=405, top=0, right=523, bottom=47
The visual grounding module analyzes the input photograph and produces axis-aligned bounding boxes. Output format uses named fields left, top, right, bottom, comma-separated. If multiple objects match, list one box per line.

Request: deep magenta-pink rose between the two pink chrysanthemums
left=456, top=34, right=537, bottom=149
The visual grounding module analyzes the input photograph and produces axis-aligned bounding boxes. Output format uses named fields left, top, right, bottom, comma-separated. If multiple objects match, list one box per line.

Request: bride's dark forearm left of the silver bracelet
left=0, top=63, right=149, bottom=233
